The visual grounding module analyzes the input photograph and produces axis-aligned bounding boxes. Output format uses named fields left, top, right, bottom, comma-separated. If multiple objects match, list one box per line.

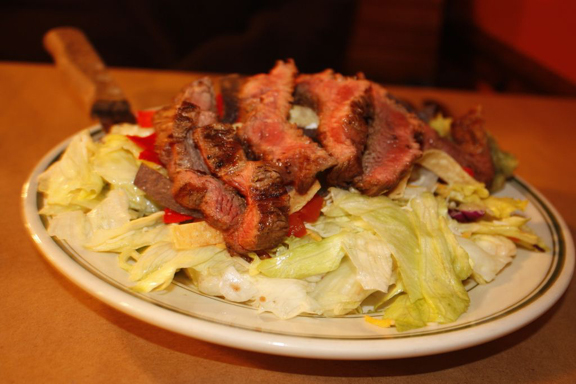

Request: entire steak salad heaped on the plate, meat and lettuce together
left=38, top=60, right=546, bottom=331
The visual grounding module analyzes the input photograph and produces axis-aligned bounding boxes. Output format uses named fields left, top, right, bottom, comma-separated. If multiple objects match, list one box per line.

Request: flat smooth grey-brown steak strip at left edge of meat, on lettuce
left=134, top=164, right=202, bottom=218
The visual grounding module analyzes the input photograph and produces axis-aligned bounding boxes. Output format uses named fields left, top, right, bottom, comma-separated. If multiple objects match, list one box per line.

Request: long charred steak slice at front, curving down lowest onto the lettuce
left=192, top=124, right=290, bottom=254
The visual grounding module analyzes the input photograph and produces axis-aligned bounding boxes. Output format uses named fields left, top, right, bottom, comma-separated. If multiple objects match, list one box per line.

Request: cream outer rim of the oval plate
left=21, top=125, right=574, bottom=360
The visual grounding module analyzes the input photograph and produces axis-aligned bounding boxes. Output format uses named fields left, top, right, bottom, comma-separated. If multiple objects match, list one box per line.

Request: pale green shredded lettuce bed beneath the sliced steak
left=39, top=126, right=546, bottom=331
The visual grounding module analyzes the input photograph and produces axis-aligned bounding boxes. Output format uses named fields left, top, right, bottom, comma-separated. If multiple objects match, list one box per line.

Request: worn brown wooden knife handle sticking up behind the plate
left=44, top=27, right=132, bottom=117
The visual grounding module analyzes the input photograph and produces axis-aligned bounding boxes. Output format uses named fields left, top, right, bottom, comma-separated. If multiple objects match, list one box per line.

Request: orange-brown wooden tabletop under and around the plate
left=0, top=63, right=576, bottom=384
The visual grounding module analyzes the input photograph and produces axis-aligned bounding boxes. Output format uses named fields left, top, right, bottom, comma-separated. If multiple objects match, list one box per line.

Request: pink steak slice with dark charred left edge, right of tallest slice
left=296, top=70, right=372, bottom=186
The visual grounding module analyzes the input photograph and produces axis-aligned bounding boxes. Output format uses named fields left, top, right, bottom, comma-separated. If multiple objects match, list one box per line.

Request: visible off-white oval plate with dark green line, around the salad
left=22, top=127, right=574, bottom=359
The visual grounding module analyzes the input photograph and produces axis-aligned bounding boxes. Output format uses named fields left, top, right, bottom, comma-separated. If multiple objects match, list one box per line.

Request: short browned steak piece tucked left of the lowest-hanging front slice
left=172, top=170, right=246, bottom=231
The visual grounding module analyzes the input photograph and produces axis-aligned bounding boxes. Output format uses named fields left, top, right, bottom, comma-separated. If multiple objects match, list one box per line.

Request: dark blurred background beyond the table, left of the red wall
left=0, top=0, right=576, bottom=96
